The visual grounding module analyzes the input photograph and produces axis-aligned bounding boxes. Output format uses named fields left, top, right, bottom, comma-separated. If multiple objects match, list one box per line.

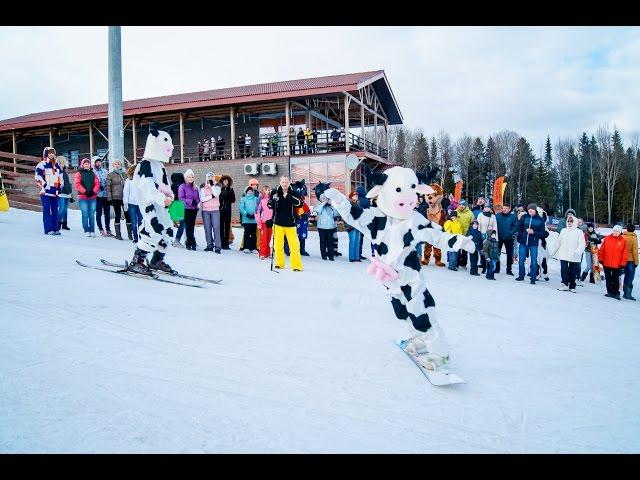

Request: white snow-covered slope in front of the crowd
left=0, top=209, right=640, bottom=453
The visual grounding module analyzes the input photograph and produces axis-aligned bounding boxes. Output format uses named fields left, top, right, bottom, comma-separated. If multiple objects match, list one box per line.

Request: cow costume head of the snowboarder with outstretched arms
left=367, top=167, right=434, bottom=220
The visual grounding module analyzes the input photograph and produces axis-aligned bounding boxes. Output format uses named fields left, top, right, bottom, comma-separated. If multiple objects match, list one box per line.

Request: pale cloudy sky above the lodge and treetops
left=0, top=27, right=640, bottom=154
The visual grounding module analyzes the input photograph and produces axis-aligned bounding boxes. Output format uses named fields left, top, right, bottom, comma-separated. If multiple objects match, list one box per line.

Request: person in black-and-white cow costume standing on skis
left=127, top=128, right=174, bottom=275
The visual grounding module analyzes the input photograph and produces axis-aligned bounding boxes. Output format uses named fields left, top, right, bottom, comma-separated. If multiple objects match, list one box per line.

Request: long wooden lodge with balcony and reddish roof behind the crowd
left=0, top=70, right=403, bottom=209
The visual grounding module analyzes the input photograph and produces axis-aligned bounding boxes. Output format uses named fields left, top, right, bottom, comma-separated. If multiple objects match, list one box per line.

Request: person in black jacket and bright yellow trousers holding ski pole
left=267, top=177, right=302, bottom=272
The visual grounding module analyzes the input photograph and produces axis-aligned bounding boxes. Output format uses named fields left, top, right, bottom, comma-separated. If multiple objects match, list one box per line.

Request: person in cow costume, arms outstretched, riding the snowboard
left=324, top=167, right=475, bottom=370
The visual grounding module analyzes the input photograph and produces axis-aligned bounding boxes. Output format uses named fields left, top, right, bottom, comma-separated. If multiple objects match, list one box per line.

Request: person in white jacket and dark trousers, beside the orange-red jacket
left=549, top=216, right=586, bottom=293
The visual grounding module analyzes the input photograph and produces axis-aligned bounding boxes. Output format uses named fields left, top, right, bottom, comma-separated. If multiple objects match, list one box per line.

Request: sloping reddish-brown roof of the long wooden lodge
left=0, top=70, right=402, bottom=132
